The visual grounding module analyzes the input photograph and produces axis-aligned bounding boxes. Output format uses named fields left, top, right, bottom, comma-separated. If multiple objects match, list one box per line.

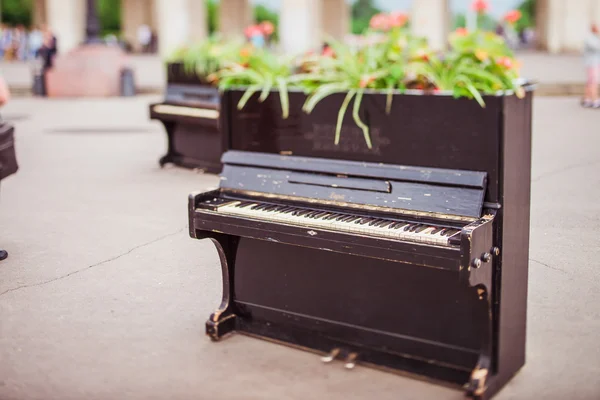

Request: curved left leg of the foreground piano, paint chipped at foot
left=206, top=233, right=238, bottom=341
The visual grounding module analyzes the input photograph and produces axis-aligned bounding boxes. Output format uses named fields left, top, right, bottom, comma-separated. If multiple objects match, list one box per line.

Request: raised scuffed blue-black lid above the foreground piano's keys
left=220, top=151, right=487, bottom=219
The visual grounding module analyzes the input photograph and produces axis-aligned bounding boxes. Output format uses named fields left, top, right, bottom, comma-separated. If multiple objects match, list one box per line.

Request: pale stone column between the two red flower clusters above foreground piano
left=410, top=0, right=450, bottom=50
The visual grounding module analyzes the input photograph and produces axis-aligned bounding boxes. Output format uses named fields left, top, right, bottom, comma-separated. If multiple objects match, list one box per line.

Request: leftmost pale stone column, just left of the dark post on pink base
left=46, top=0, right=85, bottom=53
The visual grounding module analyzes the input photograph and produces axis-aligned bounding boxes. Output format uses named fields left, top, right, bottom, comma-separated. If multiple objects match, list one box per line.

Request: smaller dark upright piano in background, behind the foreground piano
left=150, top=63, right=226, bottom=172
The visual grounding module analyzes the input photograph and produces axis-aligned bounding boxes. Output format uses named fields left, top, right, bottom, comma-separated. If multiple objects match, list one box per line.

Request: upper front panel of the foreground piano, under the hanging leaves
left=222, top=91, right=503, bottom=202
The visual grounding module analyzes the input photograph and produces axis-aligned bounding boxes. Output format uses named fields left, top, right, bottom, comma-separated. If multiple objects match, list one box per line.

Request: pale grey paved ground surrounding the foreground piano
left=0, top=97, right=600, bottom=400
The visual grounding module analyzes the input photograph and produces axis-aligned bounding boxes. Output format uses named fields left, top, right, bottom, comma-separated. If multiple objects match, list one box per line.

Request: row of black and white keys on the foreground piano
left=217, top=201, right=460, bottom=246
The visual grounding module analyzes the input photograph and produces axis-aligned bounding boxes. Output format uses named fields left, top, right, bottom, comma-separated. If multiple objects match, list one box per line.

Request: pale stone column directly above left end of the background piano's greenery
left=154, top=0, right=190, bottom=57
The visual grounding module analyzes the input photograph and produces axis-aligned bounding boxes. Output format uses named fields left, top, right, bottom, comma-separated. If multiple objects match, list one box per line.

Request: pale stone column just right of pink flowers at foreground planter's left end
left=279, top=0, right=323, bottom=54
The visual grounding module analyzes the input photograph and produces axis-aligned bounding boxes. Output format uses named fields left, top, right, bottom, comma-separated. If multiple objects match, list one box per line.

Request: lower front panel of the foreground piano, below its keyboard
left=234, top=238, right=487, bottom=368
